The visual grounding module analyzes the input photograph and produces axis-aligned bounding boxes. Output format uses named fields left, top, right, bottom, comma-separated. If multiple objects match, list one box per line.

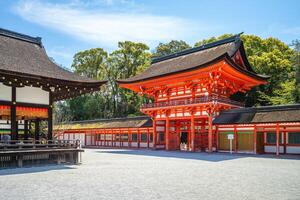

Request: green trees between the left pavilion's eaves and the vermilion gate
left=55, top=41, right=151, bottom=122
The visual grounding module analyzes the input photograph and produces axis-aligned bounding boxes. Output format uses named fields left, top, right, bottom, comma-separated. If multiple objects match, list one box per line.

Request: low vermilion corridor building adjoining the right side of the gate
left=214, top=104, right=300, bottom=155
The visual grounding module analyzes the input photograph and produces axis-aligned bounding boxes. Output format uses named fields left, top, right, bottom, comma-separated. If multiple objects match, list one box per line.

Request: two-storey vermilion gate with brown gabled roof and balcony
left=118, top=35, right=267, bottom=152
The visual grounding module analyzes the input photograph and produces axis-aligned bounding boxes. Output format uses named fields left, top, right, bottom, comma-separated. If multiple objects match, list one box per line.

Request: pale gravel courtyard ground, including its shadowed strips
left=0, top=149, right=300, bottom=200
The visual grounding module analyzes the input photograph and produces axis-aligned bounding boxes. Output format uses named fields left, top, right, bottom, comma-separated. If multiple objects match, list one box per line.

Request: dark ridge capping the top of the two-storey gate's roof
left=151, top=32, right=243, bottom=64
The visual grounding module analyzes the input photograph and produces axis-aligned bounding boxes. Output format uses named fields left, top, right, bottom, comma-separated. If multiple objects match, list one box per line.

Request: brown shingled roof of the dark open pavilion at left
left=0, top=28, right=106, bottom=99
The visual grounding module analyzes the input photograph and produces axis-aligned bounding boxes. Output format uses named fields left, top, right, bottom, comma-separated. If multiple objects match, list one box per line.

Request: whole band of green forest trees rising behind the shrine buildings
left=55, top=34, right=300, bottom=123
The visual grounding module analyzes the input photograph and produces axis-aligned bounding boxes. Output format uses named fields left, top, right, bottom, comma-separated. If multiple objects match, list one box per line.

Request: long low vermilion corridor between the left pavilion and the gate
left=55, top=116, right=153, bottom=148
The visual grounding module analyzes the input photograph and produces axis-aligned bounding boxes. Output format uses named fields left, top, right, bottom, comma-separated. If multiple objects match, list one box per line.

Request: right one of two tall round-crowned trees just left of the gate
left=108, top=41, right=151, bottom=117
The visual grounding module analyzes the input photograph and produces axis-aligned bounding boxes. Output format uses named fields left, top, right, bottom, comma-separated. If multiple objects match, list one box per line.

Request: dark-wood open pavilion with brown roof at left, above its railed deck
left=0, top=29, right=105, bottom=140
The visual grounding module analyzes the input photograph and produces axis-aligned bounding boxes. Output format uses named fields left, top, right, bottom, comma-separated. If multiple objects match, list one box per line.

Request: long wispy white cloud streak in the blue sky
left=14, top=0, right=197, bottom=47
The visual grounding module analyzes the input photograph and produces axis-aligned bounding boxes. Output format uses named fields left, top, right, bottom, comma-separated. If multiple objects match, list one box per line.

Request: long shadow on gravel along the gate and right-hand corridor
left=96, top=149, right=300, bottom=162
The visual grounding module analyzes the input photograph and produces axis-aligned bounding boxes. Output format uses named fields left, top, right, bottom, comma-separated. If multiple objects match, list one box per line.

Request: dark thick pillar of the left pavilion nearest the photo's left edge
left=10, top=86, right=18, bottom=140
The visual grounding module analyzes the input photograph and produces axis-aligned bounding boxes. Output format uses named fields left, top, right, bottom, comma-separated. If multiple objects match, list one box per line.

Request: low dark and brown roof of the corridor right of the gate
left=213, top=104, right=300, bottom=124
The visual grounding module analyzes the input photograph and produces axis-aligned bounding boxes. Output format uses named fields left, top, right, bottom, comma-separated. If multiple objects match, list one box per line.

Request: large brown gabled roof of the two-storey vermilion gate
left=118, top=34, right=267, bottom=84
